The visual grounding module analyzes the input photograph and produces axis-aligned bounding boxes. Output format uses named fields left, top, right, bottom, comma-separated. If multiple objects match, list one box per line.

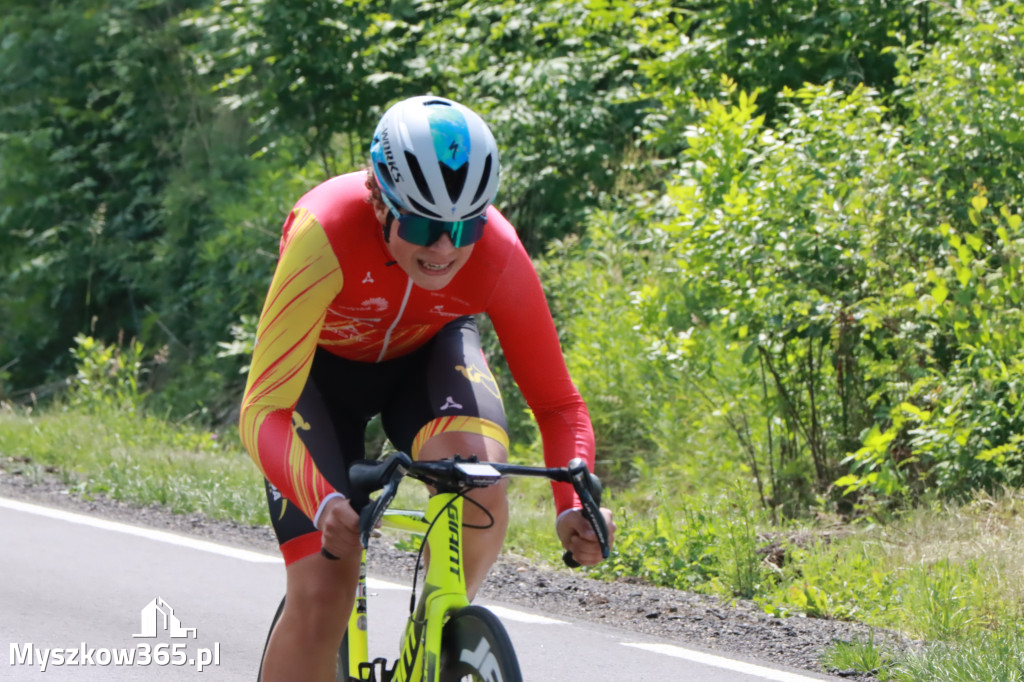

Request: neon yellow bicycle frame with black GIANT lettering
left=348, top=493, right=469, bottom=682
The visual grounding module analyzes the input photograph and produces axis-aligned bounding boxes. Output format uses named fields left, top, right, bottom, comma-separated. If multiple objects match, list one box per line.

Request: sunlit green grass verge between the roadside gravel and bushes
left=0, top=399, right=1024, bottom=682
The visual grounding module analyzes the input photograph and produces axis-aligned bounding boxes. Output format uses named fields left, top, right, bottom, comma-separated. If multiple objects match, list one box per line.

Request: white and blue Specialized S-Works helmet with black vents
left=370, top=96, right=498, bottom=222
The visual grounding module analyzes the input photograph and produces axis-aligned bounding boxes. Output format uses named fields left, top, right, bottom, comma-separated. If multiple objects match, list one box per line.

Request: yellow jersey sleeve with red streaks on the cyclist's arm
left=239, top=204, right=343, bottom=518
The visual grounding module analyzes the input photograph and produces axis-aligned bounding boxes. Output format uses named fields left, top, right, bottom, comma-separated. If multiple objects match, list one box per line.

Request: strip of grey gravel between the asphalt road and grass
left=0, top=461, right=905, bottom=681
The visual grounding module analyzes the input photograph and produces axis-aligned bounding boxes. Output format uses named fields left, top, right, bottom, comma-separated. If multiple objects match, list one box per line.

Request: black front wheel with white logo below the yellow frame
left=440, top=606, right=522, bottom=682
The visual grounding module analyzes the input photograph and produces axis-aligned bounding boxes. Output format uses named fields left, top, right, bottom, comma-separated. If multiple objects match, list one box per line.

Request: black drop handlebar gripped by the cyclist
left=322, top=453, right=610, bottom=568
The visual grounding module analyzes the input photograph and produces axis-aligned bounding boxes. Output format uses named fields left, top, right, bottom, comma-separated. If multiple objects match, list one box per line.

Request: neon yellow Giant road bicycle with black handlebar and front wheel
left=258, top=453, right=608, bottom=682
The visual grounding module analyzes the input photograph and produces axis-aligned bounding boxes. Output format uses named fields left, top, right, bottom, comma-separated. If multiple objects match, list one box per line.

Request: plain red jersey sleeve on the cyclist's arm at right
left=487, top=244, right=594, bottom=513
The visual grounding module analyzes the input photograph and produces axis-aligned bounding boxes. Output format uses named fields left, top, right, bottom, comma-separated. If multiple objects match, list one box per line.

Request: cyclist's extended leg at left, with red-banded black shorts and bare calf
left=262, top=350, right=399, bottom=682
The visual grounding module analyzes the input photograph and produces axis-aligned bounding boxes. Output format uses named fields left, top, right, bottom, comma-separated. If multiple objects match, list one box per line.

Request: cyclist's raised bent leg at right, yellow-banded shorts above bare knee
left=383, top=317, right=508, bottom=598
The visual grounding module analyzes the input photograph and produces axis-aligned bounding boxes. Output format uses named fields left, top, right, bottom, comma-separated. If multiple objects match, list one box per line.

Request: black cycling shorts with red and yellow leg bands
left=266, top=317, right=508, bottom=564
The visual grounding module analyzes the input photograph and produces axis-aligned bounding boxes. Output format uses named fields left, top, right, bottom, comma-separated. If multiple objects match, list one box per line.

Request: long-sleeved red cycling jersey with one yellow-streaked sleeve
left=240, top=172, right=594, bottom=518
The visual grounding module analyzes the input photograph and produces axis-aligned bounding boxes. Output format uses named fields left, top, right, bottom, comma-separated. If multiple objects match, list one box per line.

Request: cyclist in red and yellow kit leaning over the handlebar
left=240, top=96, right=614, bottom=680
